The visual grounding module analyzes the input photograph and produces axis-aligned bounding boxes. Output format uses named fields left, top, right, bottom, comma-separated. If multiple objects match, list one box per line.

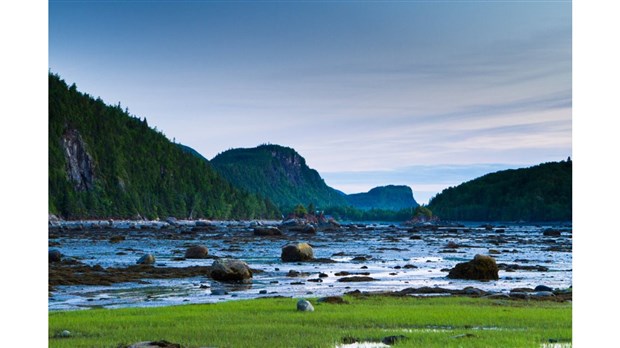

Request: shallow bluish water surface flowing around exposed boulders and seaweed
left=48, top=222, right=572, bottom=310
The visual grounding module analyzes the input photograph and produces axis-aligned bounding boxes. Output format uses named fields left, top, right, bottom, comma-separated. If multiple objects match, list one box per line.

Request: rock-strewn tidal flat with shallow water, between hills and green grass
left=48, top=221, right=572, bottom=311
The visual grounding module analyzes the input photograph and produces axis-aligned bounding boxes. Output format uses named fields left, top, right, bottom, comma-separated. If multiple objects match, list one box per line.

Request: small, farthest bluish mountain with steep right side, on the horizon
left=346, top=185, right=419, bottom=210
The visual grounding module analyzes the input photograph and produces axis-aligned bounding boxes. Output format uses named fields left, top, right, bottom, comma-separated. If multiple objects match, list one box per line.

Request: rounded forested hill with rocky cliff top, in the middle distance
left=211, top=145, right=347, bottom=211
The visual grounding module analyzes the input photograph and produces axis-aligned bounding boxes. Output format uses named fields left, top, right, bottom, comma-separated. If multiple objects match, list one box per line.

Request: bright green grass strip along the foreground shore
left=49, top=297, right=572, bottom=347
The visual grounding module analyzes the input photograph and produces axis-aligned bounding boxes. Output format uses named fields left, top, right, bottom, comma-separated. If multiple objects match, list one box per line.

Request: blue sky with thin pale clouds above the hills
left=48, top=0, right=573, bottom=203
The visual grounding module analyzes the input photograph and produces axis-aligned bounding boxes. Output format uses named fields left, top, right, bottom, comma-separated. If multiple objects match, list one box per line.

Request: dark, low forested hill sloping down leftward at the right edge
left=428, top=158, right=573, bottom=221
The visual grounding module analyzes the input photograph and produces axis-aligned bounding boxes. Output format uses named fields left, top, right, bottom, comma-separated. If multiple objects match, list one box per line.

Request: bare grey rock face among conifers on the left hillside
left=62, top=129, right=95, bottom=191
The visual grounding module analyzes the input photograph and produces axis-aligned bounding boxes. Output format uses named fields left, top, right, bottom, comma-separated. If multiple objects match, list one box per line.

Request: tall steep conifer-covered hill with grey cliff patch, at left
left=48, top=74, right=280, bottom=219
